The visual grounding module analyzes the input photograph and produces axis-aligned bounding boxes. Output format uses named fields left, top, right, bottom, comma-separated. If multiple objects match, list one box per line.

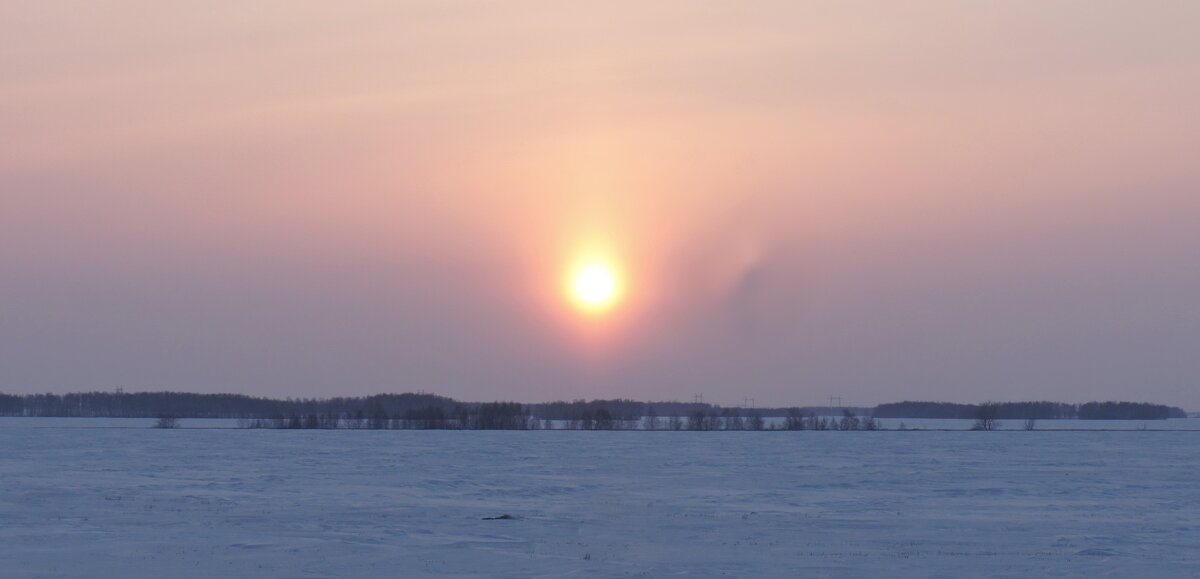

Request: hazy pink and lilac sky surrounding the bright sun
left=0, top=0, right=1200, bottom=410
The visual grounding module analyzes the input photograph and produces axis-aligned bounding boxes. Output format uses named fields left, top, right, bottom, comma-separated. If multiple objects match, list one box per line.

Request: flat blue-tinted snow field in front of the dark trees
left=0, top=419, right=1200, bottom=578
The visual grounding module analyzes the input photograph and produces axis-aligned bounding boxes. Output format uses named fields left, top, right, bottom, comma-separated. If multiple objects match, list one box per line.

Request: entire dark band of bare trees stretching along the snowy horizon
left=0, top=390, right=1187, bottom=430
